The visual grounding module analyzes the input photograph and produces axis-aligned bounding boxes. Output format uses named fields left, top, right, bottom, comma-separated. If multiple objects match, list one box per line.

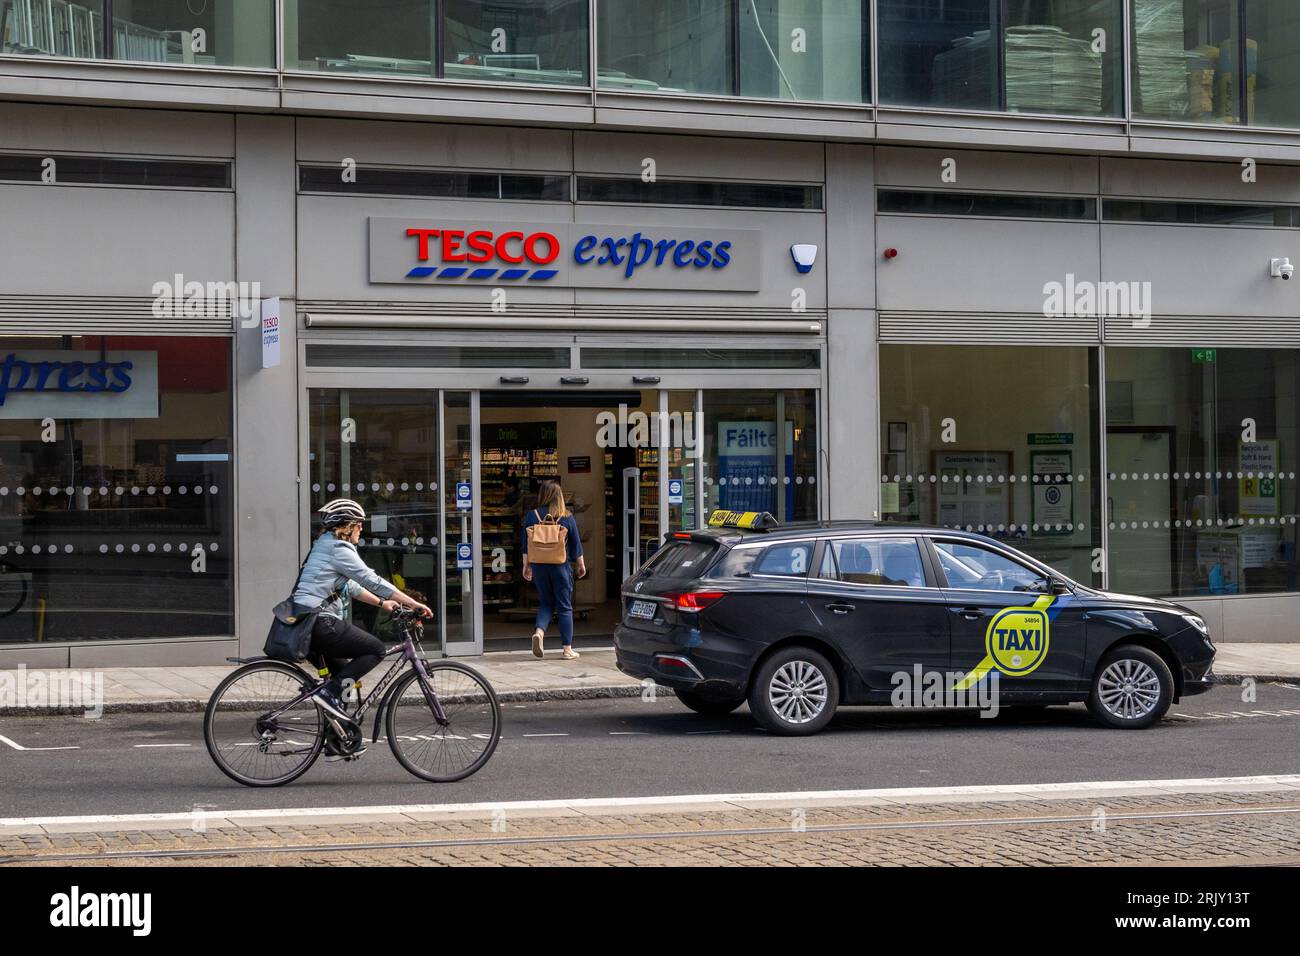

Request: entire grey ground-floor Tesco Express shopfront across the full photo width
left=0, top=98, right=1300, bottom=666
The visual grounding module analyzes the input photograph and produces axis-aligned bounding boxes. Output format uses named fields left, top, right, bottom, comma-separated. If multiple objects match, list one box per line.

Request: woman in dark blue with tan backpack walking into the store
left=523, top=481, right=586, bottom=661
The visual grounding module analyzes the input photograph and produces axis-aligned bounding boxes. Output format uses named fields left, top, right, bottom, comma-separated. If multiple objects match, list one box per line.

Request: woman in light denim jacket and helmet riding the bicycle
left=293, top=498, right=433, bottom=721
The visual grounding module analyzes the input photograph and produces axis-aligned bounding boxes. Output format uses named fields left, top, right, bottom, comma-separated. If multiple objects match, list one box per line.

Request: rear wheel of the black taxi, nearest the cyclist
left=749, top=646, right=840, bottom=736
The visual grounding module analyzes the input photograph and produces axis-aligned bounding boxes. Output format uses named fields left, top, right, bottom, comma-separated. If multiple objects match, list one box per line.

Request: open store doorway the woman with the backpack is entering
left=478, top=389, right=694, bottom=650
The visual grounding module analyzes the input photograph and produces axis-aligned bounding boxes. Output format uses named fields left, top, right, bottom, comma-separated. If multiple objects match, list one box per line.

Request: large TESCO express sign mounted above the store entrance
left=369, top=219, right=762, bottom=291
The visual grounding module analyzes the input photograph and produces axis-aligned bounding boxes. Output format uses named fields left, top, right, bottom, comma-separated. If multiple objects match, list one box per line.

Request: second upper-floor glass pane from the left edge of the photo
left=109, top=0, right=276, bottom=68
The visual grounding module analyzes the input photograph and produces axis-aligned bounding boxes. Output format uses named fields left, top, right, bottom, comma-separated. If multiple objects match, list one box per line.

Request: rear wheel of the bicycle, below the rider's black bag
left=203, top=661, right=325, bottom=787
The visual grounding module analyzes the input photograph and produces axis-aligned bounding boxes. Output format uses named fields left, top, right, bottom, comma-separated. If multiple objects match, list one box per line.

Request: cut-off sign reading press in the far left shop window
left=0, top=349, right=159, bottom=419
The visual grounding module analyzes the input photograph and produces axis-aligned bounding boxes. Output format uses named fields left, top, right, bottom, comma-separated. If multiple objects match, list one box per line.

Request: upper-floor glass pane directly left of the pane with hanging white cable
left=595, top=0, right=733, bottom=94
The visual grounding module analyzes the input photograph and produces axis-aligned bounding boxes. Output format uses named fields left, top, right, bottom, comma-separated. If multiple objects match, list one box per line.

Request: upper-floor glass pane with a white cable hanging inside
left=740, top=0, right=871, bottom=103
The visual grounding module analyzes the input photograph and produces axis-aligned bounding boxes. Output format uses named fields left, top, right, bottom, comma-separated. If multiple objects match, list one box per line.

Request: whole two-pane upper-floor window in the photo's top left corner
left=0, top=0, right=276, bottom=68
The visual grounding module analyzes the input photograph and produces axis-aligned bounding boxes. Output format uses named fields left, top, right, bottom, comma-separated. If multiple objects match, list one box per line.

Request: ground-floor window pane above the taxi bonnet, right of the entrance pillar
left=880, top=345, right=1101, bottom=584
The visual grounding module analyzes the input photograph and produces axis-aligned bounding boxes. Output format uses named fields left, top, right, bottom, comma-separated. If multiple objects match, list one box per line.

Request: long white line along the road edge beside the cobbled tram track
left=0, top=774, right=1300, bottom=832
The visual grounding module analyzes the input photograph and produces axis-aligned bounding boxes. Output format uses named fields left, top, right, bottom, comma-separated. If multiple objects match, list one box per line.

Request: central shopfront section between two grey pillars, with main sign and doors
left=287, top=122, right=828, bottom=654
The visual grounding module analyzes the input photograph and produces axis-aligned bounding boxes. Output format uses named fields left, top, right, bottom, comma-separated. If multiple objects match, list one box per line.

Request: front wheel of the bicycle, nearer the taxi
left=385, top=661, right=501, bottom=783
